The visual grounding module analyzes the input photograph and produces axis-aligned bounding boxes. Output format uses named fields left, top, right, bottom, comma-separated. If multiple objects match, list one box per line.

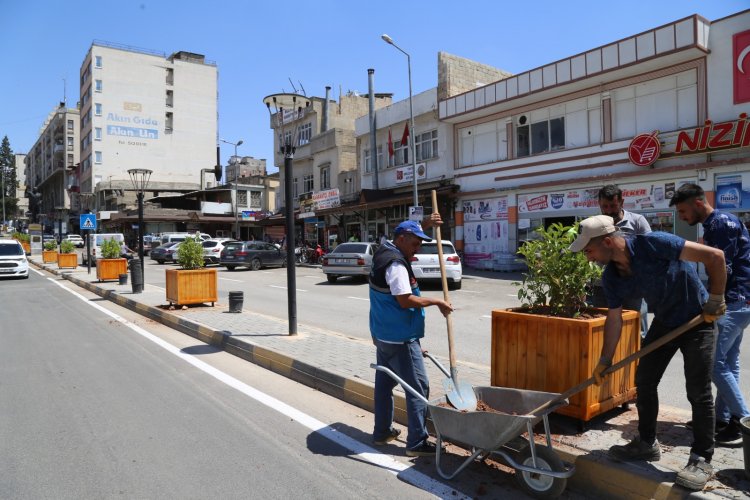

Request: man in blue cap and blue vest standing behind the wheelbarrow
left=369, top=212, right=453, bottom=457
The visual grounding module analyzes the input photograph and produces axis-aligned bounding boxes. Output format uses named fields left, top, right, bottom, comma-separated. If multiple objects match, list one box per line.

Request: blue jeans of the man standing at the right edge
left=713, top=300, right=750, bottom=422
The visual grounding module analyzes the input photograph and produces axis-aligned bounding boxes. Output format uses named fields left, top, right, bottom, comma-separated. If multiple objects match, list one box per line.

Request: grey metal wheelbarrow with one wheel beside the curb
left=370, top=354, right=575, bottom=498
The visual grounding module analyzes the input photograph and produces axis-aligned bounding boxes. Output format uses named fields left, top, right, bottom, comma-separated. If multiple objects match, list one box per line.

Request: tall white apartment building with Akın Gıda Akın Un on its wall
left=78, top=42, right=218, bottom=207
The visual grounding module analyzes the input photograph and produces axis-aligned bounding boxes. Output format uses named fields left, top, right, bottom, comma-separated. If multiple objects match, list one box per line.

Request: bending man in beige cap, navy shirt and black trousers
left=570, top=215, right=727, bottom=491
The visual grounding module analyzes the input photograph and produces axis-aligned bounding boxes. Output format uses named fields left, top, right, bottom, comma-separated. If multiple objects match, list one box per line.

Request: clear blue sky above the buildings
left=0, top=0, right=750, bottom=171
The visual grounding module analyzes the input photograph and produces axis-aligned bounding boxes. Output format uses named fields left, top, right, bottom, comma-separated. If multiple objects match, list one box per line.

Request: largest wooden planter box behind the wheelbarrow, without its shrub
left=491, top=309, right=641, bottom=422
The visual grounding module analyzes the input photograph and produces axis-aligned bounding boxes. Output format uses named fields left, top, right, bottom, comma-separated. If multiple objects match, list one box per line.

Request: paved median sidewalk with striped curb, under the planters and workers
left=36, top=256, right=750, bottom=498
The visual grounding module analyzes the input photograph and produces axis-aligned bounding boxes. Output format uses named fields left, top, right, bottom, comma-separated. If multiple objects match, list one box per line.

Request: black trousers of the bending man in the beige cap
left=635, top=319, right=715, bottom=462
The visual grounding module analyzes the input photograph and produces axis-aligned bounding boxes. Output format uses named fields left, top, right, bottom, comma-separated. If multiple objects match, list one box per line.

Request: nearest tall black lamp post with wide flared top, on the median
left=263, top=94, right=310, bottom=335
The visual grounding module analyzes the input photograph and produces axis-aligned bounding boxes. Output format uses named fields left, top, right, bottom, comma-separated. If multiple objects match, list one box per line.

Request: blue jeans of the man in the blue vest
left=373, top=339, right=430, bottom=449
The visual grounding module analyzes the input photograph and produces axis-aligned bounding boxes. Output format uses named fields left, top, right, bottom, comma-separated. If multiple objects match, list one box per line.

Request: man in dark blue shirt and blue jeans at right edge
left=669, top=184, right=750, bottom=445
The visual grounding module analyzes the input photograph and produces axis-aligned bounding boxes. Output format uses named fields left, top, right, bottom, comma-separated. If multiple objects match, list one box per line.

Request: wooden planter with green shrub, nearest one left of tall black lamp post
left=165, top=237, right=218, bottom=306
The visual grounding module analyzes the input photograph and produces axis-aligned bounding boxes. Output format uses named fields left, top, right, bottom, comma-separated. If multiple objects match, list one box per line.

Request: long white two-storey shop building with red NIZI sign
left=439, top=11, right=750, bottom=270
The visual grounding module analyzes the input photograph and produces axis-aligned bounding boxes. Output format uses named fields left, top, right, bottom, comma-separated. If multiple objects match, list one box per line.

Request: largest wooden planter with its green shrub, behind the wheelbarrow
left=491, top=223, right=641, bottom=422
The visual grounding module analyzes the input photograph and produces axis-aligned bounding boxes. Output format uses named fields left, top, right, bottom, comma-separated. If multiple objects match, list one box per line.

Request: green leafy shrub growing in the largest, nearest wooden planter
left=514, top=223, right=602, bottom=318
